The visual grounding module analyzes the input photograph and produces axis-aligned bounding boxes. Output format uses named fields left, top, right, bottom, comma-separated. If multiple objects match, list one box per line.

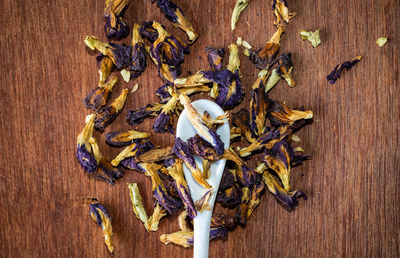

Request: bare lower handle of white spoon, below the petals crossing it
left=193, top=210, right=212, bottom=258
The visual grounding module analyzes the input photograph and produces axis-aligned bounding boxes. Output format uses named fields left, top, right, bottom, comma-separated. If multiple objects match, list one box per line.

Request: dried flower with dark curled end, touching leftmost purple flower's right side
left=89, top=137, right=124, bottom=184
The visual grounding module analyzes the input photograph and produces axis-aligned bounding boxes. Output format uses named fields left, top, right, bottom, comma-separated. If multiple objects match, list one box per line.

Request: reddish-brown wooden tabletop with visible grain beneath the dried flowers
left=0, top=0, right=400, bottom=257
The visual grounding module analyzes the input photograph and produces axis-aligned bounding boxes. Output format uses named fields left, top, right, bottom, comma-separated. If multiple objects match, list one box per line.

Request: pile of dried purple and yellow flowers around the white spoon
left=77, top=0, right=313, bottom=252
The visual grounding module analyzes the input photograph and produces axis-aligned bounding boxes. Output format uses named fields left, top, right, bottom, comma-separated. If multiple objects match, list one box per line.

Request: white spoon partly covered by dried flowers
left=176, top=99, right=230, bottom=258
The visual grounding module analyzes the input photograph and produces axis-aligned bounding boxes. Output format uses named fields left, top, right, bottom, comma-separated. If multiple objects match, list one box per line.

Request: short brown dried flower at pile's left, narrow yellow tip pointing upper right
left=83, top=76, right=118, bottom=110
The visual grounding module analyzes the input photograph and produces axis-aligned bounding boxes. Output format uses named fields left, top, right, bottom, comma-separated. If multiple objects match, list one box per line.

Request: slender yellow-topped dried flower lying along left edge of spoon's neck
left=168, top=159, right=197, bottom=219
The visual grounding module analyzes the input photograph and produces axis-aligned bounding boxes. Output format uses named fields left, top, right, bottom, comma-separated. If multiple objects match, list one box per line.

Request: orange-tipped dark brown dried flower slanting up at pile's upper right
left=248, top=26, right=285, bottom=69
